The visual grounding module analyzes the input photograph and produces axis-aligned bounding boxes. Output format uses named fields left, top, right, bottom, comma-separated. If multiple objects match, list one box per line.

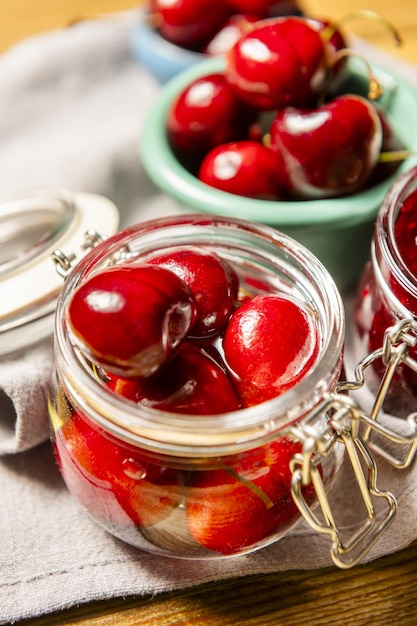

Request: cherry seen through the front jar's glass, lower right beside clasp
left=186, top=439, right=314, bottom=554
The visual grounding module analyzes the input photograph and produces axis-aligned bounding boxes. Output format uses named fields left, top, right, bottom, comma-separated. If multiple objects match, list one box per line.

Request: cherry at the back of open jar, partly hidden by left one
left=148, top=246, right=238, bottom=337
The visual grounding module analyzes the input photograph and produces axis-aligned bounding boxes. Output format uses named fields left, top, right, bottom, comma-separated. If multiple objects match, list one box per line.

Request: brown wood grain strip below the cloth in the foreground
left=21, top=542, right=417, bottom=626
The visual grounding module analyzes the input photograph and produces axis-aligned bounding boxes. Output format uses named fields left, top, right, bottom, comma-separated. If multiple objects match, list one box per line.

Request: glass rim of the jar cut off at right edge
left=372, top=167, right=417, bottom=317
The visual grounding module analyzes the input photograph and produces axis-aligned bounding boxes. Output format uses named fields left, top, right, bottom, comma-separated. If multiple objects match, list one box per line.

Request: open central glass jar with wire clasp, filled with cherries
left=50, top=215, right=395, bottom=567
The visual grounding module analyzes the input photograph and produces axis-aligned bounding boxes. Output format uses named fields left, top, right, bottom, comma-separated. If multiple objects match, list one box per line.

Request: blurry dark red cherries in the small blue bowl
left=148, top=0, right=298, bottom=55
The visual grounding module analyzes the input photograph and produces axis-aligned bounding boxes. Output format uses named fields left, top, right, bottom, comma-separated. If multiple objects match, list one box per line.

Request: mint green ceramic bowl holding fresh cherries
left=140, top=58, right=417, bottom=289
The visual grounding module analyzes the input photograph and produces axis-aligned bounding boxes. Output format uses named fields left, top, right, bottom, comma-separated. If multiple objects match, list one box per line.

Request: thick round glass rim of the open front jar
left=55, top=215, right=345, bottom=457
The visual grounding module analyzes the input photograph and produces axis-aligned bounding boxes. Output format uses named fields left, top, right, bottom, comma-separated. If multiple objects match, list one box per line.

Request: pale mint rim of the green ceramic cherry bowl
left=139, top=57, right=417, bottom=227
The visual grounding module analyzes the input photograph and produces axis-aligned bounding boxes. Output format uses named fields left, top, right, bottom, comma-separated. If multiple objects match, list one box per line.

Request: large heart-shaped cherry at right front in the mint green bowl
left=270, top=95, right=382, bottom=198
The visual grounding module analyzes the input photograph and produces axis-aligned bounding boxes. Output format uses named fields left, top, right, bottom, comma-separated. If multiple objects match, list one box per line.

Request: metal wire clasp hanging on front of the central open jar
left=291, top=395, right=397, bottom=569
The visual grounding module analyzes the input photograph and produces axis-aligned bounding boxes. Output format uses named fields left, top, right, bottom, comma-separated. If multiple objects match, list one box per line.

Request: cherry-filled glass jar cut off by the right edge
left=353, top=167, right=417, bottom=418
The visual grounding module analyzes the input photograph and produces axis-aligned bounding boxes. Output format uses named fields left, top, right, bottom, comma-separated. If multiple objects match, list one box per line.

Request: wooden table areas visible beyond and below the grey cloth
left=4, top=0, right=417, bottom=626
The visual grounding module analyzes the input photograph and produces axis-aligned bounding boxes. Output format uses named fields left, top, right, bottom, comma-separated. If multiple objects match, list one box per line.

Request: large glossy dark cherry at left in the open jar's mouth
left=67, top=264, right=196, bottom=376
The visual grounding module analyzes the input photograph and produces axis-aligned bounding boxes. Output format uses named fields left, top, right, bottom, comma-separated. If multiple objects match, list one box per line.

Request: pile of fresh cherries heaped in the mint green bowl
left=166, top=16, right=406, bottom=200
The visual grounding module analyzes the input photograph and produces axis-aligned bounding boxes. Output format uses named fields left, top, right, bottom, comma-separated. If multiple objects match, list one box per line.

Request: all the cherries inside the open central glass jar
left=54, top=245, right=322, bottom=557
